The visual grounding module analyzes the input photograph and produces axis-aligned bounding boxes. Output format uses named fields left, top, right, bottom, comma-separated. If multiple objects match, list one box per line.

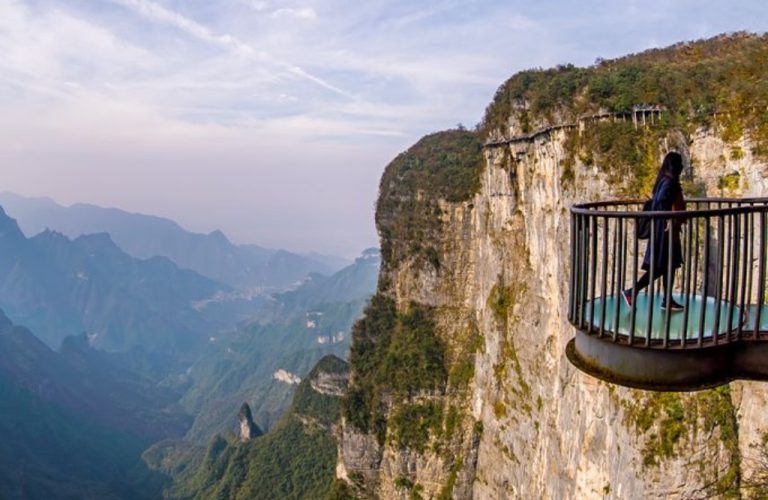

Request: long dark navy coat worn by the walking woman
left=643, top=177, right=685, bottom=276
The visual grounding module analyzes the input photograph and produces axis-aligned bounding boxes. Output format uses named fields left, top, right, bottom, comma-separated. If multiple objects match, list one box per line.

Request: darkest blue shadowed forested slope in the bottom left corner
left=0, top=311, right=191, bottom=500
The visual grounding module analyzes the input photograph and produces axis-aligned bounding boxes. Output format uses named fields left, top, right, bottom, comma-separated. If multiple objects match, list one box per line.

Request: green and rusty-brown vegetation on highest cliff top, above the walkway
left=480, top=32, right=768, bottom=153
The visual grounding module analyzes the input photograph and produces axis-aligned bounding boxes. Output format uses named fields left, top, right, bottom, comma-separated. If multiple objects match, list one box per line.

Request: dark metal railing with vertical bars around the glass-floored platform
left=568, top=198, right=768, bottom=349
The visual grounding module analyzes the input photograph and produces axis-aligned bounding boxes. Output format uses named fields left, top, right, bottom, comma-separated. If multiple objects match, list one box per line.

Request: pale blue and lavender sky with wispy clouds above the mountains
left=0, top=0, right=768, bottom=257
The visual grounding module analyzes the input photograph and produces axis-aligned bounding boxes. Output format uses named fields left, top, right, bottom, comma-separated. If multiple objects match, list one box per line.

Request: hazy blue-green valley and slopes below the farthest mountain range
left=0, top=201, right=380, bottom=499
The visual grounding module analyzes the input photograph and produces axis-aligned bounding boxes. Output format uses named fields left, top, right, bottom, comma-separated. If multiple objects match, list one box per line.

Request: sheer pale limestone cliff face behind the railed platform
left=337, top=120, right=768, bottom=498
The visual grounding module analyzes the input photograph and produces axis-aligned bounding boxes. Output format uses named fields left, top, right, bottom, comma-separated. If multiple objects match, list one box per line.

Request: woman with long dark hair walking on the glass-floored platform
left=622, top=152, right=685, bottom=311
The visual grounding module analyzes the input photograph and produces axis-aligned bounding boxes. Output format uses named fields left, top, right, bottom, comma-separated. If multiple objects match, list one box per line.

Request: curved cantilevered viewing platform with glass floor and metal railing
left=566, top=198, right=768, bottom=391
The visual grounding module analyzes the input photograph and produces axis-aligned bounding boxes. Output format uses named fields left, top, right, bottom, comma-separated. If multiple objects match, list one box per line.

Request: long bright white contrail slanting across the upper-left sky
left=111, top=0, right=354, bottom=99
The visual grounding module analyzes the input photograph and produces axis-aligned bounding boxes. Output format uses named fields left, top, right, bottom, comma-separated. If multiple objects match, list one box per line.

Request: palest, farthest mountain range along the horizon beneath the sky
left=0, top=192, right=349, bottom=289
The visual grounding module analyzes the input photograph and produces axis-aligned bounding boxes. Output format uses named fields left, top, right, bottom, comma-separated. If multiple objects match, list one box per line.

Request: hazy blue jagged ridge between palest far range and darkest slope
left=0, top=208, right=230, bottom=355
